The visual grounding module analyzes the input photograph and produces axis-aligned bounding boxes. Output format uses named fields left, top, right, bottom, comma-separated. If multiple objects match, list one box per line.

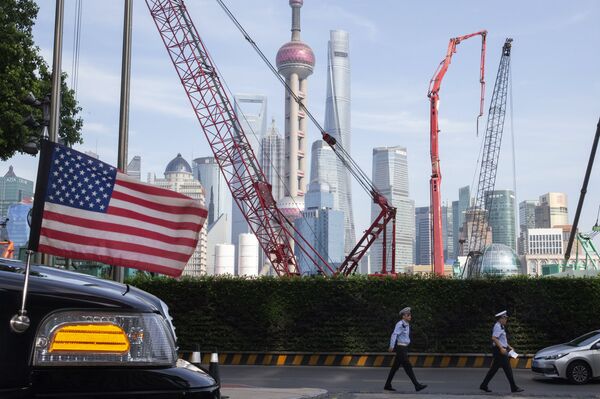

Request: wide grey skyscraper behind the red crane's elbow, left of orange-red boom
left=371, top=146, right=415, bottom=272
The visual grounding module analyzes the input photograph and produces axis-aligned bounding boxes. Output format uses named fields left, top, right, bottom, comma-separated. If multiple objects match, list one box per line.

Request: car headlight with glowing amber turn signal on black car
left=33, top=310, right=177, bottom=366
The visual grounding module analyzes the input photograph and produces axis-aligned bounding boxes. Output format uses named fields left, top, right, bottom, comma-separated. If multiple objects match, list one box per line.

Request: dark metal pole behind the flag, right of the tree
left=113, top=0, right=133, bottom=283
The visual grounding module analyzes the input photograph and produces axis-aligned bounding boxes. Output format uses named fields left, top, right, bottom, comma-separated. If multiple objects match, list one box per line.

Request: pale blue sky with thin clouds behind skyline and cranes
left=0, top=0, right=600, bottom=244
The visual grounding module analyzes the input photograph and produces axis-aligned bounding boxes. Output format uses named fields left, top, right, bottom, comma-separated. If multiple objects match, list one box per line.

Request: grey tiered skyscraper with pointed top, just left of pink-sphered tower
left=260, top=119, right=285, bottom=201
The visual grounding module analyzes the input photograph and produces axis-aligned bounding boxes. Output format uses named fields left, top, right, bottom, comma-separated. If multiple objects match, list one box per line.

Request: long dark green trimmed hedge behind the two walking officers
left=129, top=276, right=600, bottom=353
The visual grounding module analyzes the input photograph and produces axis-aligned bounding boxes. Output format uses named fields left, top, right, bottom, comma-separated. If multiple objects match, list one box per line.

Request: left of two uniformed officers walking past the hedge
left=383, top=307, right=427, bottom=392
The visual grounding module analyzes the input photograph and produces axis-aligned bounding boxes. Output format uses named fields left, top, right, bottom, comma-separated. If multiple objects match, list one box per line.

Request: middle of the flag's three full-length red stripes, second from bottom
left=40, top=225, right=193, bottom=263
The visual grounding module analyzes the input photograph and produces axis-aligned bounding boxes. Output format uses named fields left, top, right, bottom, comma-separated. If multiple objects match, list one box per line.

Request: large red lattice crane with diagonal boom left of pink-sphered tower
left=146, top=0, right=396, bottom=276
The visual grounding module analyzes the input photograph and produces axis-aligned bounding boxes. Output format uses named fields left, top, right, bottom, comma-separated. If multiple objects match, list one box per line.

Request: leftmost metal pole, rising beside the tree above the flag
left=49, top=0, right=65, bottom=142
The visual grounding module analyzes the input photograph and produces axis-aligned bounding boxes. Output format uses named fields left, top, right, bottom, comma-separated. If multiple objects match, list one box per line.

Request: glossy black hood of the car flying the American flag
left=0, top=259, right=162, bottom=313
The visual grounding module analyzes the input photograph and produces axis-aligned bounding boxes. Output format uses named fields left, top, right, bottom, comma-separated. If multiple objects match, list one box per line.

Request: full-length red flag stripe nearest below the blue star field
left=44, top=210, right=198, bottom=248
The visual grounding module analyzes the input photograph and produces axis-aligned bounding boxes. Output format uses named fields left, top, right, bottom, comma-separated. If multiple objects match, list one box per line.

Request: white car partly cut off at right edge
left=531, top=330, right=600, bottom=384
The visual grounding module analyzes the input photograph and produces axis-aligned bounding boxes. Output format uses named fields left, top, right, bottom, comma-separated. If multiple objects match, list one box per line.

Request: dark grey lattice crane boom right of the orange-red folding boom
left=462, top=38, right=513, bottom=277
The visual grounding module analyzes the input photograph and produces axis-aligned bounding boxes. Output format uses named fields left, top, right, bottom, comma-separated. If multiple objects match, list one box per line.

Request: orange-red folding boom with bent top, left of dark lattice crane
left=427, top=30, right=487, bottom=275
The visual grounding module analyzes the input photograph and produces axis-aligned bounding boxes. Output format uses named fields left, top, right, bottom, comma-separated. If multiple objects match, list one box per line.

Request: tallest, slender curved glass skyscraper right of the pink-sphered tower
left=325, top=30, right=356, bottom=253
